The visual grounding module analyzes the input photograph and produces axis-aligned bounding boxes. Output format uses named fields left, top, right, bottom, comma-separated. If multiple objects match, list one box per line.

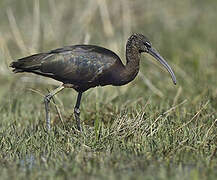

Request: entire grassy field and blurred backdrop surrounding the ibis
left=0, top=0, right=217, bottom=180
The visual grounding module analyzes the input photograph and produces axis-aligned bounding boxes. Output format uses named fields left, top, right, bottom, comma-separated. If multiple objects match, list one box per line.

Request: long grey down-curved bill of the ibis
left=148, top=48, right=176, bottom=85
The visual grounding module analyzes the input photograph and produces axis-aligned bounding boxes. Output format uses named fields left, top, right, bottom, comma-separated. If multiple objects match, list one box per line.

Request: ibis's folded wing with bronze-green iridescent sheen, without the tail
left=40, top=45, right=120, bottom=84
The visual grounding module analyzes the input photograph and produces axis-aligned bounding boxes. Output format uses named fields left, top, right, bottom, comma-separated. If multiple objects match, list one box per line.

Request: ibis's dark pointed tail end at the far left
left=10, top=53, right=47, bottom=73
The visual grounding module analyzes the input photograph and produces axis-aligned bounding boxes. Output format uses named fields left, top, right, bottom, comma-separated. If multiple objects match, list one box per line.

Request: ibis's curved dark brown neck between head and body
left=118, top=38, right=141, bottom=84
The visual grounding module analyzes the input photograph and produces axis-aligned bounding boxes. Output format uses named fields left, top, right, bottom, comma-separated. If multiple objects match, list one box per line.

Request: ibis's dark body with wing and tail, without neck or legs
left=11, top=45, right=127, bottom=92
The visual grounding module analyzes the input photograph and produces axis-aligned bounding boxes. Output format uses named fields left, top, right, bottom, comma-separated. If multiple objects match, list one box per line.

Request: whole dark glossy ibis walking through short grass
left=10, top=34, right=176, bottom=131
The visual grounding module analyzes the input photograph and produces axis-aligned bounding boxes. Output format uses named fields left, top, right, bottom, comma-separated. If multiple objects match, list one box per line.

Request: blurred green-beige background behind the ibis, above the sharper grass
left=0, top=0, right=217, bottom=126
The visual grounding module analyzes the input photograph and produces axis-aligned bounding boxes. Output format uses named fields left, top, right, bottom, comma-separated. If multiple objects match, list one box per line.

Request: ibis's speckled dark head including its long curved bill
left=128, top=33, right=176, bottom=84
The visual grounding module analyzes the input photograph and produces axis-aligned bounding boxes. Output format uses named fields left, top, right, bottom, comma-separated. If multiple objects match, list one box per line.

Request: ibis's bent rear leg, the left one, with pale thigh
left=44, top=85, right=64, bottom=131
